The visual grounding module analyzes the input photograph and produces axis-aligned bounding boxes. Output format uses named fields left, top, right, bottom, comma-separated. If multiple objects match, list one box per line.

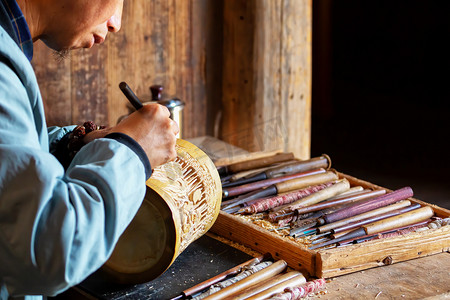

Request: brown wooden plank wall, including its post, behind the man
left=33, top=0, right=312, bottom=158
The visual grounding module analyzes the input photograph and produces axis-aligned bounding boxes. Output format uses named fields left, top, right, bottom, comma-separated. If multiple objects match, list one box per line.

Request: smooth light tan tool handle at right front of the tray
left=363, top=206, right=434, bottom=234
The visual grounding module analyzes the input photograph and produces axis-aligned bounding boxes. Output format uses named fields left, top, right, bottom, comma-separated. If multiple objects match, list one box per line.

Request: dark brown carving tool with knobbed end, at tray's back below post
left=222, top=154, right=331, bottom=188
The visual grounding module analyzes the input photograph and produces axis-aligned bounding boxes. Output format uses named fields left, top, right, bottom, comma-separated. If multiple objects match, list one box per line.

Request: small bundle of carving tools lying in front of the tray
left=171, top=254, right=325, bottom=300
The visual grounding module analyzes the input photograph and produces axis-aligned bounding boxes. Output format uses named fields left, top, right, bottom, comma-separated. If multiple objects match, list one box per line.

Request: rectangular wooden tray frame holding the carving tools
left=210, top=172, right=450, bottom=278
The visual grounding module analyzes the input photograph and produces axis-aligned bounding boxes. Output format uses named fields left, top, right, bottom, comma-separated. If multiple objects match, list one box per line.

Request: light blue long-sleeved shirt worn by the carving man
left=0, top=0, right=151, bottom=300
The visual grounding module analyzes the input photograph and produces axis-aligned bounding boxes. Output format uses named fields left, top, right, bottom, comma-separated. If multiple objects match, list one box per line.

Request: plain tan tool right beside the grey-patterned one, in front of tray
left=204, top=260, right=287, bottom=300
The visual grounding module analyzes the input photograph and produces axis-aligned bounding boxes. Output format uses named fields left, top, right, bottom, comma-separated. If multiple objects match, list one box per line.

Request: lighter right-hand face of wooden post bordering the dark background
left=281, top=0, right=312, bottom=159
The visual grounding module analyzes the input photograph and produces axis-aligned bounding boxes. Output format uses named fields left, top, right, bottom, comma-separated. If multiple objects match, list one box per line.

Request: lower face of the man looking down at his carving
left=17, top=0, right=124, bottom=51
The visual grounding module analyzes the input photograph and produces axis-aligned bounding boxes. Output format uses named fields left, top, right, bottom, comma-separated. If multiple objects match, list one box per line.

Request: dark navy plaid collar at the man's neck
left=2, top=0, right=33, bottom=61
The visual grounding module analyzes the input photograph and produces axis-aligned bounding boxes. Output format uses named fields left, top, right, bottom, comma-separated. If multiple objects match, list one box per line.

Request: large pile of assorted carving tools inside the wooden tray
left=218, top=153, right=442, bottom=249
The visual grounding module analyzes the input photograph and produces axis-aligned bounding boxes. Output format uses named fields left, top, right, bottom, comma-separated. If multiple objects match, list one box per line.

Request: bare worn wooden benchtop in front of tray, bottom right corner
left=318, top=253, right=450, bottom=300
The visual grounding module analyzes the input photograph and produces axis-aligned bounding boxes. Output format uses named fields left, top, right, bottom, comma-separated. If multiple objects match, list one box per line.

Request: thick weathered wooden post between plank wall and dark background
left=220, top=0, right=312, bottom=158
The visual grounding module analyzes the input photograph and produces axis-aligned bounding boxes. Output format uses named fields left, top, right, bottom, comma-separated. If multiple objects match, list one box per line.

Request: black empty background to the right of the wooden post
left=311, top=0, right=450, bottom=208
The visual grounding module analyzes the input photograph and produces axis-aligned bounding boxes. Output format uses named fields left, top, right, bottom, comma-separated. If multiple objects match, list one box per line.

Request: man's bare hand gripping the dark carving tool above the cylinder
left=107, top=103, right=180, bottom=168
